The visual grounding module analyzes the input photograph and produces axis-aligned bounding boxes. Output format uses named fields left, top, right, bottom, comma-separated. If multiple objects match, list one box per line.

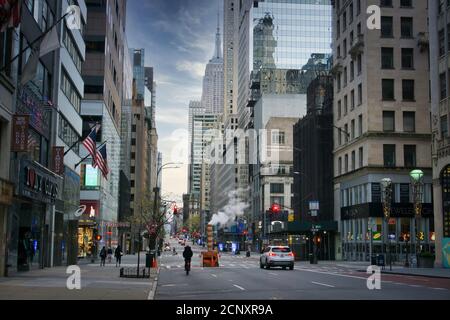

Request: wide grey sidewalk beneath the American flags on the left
left=0, top=253, right=159, bottom=300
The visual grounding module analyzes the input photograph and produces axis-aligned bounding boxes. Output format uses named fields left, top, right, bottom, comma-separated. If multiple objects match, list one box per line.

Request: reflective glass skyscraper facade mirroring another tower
left=250, top=0, right=332, bottom=71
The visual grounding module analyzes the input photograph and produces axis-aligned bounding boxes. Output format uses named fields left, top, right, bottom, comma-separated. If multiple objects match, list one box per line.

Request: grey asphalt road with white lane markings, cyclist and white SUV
left=154, top=242, right=450, bottom=300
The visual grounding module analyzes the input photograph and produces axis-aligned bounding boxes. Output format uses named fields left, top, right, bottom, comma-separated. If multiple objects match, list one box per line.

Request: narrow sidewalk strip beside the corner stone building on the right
left=297, top=261, right=450, bottom=279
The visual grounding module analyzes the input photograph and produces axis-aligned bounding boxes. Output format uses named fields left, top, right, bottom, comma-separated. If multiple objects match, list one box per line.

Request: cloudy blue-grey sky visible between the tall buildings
left=126, top=0, right=223, bottom=205
